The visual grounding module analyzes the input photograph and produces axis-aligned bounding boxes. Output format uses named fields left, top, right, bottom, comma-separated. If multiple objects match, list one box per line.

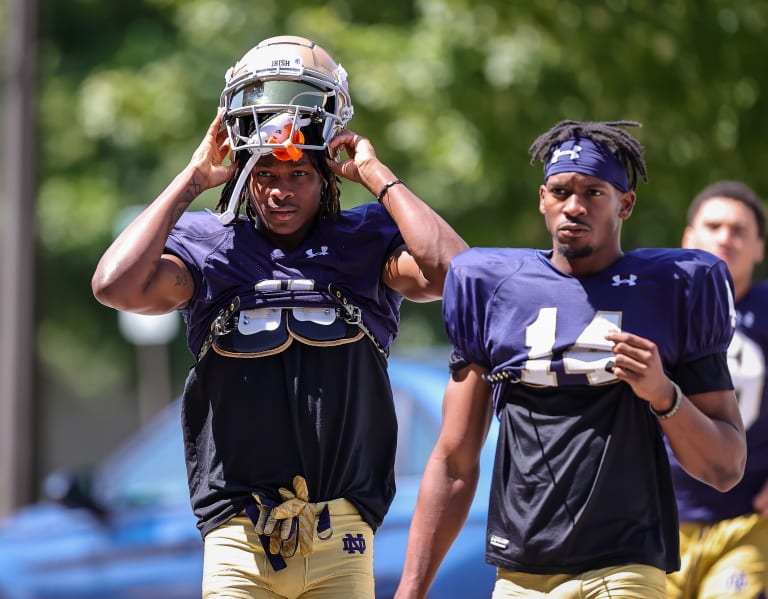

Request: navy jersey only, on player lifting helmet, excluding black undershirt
left=166, top=202, right=403, bottom=355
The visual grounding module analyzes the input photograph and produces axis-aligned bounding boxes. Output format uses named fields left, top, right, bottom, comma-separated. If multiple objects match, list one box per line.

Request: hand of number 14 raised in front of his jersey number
left=605, top=332, right=673, bottom=412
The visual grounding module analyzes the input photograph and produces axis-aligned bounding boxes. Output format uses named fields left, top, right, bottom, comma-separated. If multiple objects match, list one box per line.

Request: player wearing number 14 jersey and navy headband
left=397, top=121, right=746, bottom=599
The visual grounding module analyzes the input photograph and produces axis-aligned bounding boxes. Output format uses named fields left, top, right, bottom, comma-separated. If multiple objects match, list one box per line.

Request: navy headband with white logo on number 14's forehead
left=544, top=137, right=630, bottom=191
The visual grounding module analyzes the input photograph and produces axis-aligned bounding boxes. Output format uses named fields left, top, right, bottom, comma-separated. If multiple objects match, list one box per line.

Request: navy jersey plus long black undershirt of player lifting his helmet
left=166, top=203, right=403, bottom=536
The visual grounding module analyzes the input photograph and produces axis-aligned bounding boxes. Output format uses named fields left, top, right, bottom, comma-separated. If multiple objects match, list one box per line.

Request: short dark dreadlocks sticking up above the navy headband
left=528, top=121, right=648, bottom=190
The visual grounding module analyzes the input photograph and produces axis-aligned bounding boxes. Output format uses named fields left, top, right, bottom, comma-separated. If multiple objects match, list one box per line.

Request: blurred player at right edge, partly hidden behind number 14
left=667, top=181, right=768, bottom=599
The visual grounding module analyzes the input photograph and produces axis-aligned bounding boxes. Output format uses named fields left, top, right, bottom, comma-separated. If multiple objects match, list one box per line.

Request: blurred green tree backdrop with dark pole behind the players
left=0, top=0, right=768, bottom=516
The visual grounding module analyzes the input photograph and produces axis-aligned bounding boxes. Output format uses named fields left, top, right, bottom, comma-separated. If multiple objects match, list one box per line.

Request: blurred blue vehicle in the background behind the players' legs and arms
left=0, top=358, right=497, bottom=599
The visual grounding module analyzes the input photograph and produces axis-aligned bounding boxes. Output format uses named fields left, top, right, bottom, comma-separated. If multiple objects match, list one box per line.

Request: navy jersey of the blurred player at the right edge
left=669, top=281, right=768, bottom=522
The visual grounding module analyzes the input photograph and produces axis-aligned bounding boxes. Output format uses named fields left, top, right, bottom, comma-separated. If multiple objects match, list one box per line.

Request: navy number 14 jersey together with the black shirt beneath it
left=443, top=249, right=735, bottom=574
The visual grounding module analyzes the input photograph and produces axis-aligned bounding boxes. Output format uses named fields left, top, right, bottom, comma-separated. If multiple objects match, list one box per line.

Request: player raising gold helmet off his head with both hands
left=93, top=36, right=466, bottom=598
